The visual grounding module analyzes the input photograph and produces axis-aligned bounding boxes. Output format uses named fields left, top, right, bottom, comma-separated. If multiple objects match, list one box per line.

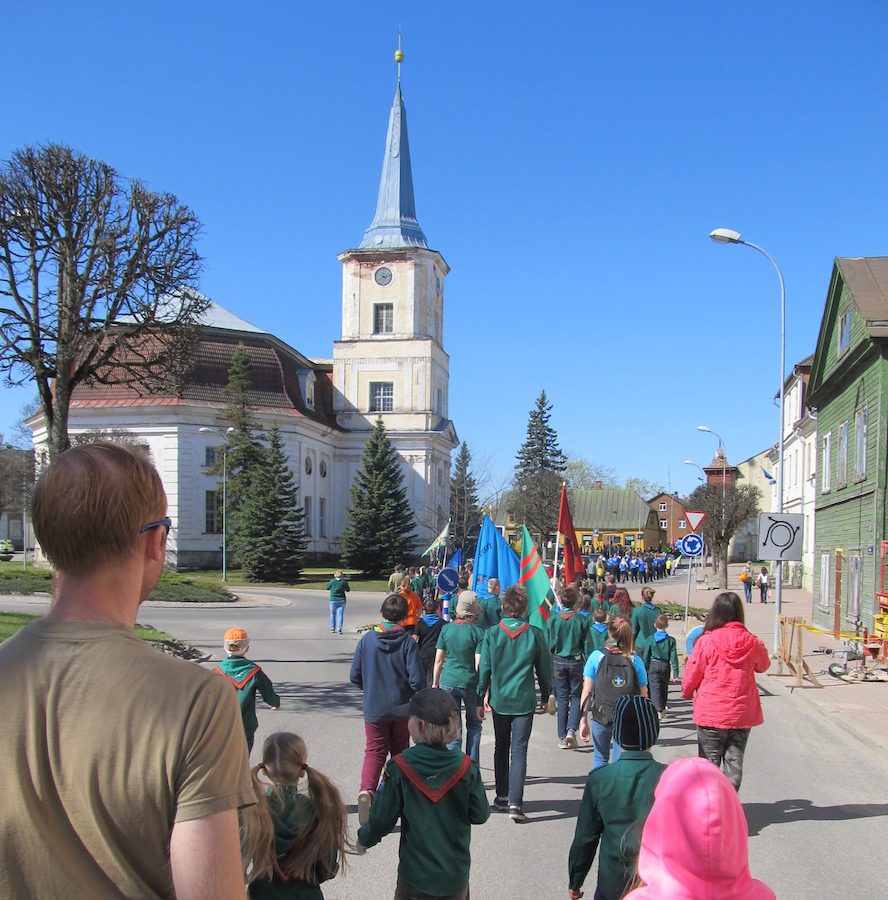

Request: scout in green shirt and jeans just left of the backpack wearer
left=549, top=585, right=589, bottom=750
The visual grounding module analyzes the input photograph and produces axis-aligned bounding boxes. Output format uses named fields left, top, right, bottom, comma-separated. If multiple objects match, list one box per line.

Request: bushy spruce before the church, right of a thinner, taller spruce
left=230, top=425, right=306, bottom=584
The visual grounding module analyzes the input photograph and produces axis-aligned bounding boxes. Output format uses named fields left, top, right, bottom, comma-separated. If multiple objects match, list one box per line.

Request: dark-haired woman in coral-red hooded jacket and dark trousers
left=681, top=591, right=771, bottom=789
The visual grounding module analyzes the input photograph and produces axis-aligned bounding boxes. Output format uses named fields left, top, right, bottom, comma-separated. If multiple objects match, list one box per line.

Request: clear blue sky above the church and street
left=0, top=0, right=888, bottom=493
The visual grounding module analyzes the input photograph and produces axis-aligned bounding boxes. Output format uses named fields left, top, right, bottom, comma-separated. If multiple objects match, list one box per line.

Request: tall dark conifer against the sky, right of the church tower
left=511, top=391, right=567, bottom=558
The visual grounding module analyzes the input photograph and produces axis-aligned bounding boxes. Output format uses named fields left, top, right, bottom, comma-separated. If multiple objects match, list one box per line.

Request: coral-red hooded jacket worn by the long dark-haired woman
left=681, top=622, right=771, bottom=728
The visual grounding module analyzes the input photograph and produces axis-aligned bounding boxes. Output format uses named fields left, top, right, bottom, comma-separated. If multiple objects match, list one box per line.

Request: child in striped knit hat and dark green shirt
left=567, top=696, right=666, bottom=900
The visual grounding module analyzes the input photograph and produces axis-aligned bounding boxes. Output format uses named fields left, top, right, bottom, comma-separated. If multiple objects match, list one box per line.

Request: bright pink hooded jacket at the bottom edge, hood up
left=625, top=757, right=776, bottom=900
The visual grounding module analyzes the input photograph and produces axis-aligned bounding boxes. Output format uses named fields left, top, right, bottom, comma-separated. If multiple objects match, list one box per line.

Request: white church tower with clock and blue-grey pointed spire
left=333, top=66, right=458, bottom=543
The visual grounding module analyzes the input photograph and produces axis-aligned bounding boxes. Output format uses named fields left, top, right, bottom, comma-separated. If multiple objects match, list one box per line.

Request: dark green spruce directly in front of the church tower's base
left=342, top=416, right=415, bottom=576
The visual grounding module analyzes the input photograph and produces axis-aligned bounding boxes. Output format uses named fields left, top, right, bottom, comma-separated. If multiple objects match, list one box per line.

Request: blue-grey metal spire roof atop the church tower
left=358, top=82, right=428, bottom=250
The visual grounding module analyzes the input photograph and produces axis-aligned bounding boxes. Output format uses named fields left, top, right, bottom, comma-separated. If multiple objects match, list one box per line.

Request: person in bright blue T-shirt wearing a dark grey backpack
left=580, top=619, right=647, bottom=769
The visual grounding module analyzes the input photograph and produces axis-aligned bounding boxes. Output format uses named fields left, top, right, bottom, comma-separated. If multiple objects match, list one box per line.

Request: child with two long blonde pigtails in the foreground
left=243, top=732, right=353, bottom=900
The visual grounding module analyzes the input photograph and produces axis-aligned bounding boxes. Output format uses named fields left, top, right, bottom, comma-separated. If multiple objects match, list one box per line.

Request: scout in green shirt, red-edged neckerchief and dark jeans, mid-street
left=478, top=585, right=552, bottom=822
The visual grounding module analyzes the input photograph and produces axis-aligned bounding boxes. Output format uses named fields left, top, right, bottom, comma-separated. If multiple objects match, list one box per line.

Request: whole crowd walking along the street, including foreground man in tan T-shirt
left=0, top=442, right=774, bottom=900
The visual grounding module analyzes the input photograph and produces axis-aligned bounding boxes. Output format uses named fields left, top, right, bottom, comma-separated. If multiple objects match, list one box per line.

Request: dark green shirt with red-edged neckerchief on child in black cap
left=358, top=744, right=490, bottom=897
